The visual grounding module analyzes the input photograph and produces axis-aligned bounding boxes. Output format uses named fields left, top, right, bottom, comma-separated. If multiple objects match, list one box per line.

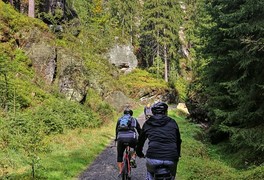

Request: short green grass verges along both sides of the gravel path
left=0, top=107, right=264, bottom=180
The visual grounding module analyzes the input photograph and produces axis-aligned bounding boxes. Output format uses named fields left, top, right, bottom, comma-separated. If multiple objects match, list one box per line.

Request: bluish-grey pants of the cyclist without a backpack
left=146, top=158, right=178, bottom=180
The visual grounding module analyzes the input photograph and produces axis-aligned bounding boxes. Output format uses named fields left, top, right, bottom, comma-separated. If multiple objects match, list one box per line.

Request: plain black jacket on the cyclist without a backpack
left=136, top=114, right=181, bottom=161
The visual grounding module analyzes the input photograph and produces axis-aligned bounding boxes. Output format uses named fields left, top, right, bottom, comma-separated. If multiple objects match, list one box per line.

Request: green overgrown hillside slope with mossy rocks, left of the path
left=0, top=1, right=175, bottom=178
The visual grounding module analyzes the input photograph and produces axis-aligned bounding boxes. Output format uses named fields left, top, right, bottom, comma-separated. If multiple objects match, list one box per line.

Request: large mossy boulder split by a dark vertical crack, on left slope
left=25, top=39, right=89, bottom=102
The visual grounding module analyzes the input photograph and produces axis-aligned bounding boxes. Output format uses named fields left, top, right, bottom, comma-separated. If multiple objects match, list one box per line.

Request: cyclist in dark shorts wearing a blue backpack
left=116, top=109, right=141, bottom=177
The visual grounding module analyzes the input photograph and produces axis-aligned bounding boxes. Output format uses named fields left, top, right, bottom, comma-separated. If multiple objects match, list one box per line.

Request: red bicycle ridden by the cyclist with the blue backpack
left=121, top=143, right=134, bottom=180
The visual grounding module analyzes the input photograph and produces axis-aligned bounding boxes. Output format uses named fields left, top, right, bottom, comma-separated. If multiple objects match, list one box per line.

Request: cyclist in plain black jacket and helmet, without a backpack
left=136, top=102, right=181, bottom=180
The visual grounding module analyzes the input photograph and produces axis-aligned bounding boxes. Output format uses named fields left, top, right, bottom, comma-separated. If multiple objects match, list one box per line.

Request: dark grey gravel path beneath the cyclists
left=79, top=114, right=147, bottom=180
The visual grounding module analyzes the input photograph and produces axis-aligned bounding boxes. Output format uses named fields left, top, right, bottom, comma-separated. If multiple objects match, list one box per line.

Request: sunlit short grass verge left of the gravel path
left=1, top=121, right=115, bottom=180
